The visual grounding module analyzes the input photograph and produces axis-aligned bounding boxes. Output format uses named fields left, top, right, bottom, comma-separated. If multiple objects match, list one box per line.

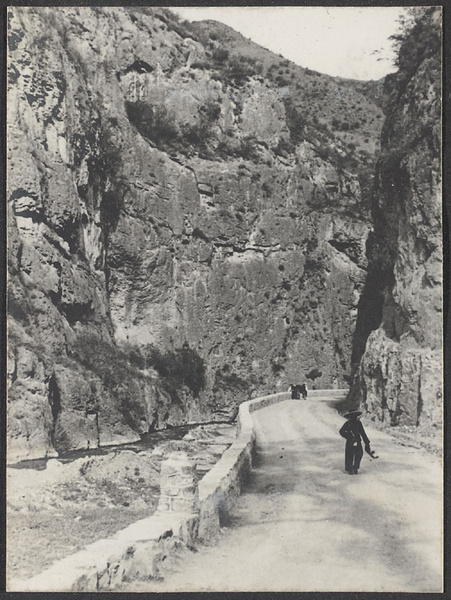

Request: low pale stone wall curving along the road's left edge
left=12, top=390, right=347, bottom=592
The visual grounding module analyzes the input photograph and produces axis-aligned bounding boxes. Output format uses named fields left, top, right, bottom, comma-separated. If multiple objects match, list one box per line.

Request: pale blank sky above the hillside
left=171, top=6, right=402, bottom=80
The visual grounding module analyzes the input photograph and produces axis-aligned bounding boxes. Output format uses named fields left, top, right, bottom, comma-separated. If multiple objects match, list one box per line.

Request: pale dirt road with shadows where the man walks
left=130, top=400, right=443, bottom=592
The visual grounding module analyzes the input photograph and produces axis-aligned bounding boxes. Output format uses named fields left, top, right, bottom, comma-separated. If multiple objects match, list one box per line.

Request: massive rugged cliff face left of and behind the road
left=8, top=8, right=378, bottom=460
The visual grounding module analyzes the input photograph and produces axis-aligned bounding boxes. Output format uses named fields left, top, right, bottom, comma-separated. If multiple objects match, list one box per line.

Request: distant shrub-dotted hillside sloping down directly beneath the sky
left=192, top=21, right=383, bottom=168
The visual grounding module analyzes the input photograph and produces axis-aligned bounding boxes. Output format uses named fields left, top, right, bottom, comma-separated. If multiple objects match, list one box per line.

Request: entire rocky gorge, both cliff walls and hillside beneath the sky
left=8, top=7, right=442, bottom=462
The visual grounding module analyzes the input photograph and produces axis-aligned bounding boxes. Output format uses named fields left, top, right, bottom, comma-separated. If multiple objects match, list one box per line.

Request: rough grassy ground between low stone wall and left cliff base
left=7, top=423, right=237, bottom=585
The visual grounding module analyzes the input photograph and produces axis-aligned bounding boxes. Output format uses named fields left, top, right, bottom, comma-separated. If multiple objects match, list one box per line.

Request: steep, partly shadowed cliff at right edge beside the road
left=349, top=9, right=443, bottom=427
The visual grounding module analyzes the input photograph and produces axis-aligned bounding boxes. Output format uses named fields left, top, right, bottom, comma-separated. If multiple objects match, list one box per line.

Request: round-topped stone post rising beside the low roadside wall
left=158, top=452, right=199, bottom=514
